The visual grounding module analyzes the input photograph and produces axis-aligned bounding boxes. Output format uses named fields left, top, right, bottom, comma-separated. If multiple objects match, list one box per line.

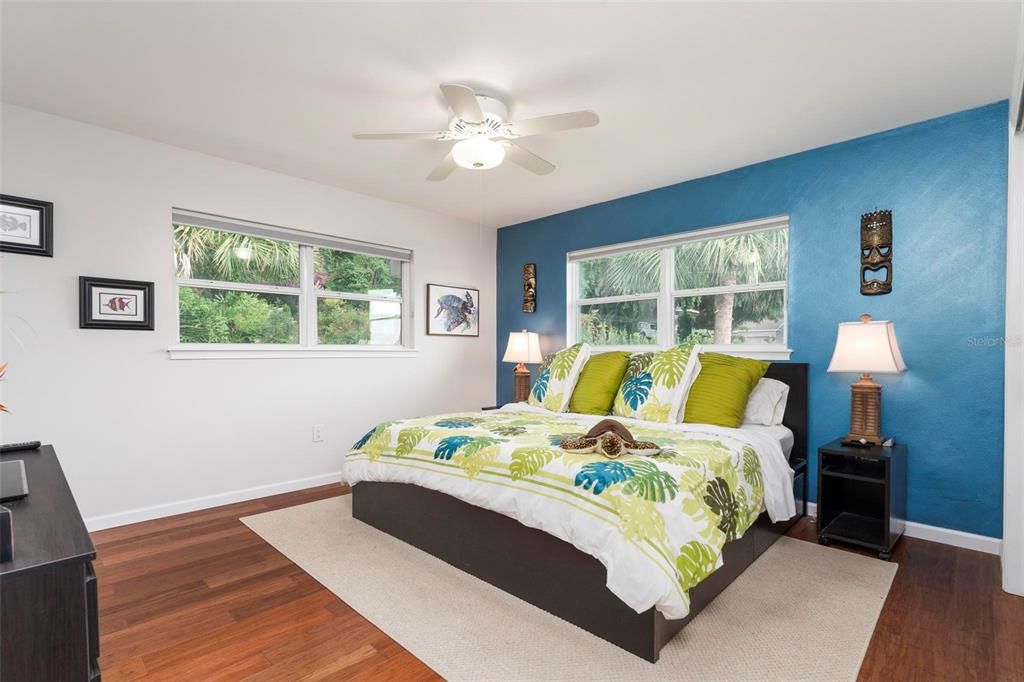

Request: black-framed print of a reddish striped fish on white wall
left=78, top=276, right=153, bottom=330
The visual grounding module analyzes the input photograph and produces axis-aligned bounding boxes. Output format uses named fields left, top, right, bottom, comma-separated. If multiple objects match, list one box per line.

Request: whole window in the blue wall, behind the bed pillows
left=566, top=218, right=790, bottom=359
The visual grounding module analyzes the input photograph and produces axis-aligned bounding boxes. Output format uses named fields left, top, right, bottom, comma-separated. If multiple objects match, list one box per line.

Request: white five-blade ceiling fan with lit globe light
left=352, top=83, right=600, bottom=181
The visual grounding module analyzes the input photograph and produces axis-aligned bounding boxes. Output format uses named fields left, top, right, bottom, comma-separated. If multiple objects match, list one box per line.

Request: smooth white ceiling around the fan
left=0, top=1, right=1019, bottom=226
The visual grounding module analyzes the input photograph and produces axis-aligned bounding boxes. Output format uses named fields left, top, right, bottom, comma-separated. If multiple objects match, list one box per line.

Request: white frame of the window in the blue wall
left=565, top=216, right=793, bottom=360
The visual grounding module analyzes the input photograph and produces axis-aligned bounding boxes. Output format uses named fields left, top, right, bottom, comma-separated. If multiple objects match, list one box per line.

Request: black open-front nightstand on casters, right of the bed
left=818, top=438, right=907, bottom=561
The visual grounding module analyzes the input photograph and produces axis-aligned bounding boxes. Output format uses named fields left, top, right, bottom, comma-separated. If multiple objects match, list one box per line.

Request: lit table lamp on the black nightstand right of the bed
left=828, top=314, right=906, bottom=445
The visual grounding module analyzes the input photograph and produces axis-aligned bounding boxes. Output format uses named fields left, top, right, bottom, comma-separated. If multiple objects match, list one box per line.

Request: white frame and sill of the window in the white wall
left=168, top=209, right=417, bottom=359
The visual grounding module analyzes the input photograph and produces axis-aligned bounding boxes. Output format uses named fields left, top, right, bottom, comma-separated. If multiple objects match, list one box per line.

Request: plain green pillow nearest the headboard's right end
left=683, top=353, right=769, bottom=428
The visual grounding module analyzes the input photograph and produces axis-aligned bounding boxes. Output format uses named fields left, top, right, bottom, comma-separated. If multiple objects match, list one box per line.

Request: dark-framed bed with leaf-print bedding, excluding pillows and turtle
left=345, top=363, right=807, bottom=663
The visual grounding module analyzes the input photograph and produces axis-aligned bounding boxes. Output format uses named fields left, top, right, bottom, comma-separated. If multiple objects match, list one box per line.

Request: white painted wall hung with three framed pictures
left=0, top=105, right=495, bottom=528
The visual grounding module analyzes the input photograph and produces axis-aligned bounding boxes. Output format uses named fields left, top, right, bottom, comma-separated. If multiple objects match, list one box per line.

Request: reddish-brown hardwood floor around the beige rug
left=93, top=485, right=1024, bottom=682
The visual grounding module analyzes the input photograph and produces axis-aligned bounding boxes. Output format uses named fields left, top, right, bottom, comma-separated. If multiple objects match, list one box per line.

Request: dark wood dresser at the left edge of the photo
left=0, top=445, right=99, bottom=682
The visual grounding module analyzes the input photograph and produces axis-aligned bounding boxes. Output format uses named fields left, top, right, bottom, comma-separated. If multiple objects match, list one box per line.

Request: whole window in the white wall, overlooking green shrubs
left=172, top=210, right=412, bottom=356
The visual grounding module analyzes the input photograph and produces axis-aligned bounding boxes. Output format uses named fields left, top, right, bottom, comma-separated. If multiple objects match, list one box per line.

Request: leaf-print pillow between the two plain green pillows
left=611, top=346, right=696, bottom=424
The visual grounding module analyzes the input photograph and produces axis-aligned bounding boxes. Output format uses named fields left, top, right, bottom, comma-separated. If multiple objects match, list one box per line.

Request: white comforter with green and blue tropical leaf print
left=343, top=403, right=796, bottom=619
